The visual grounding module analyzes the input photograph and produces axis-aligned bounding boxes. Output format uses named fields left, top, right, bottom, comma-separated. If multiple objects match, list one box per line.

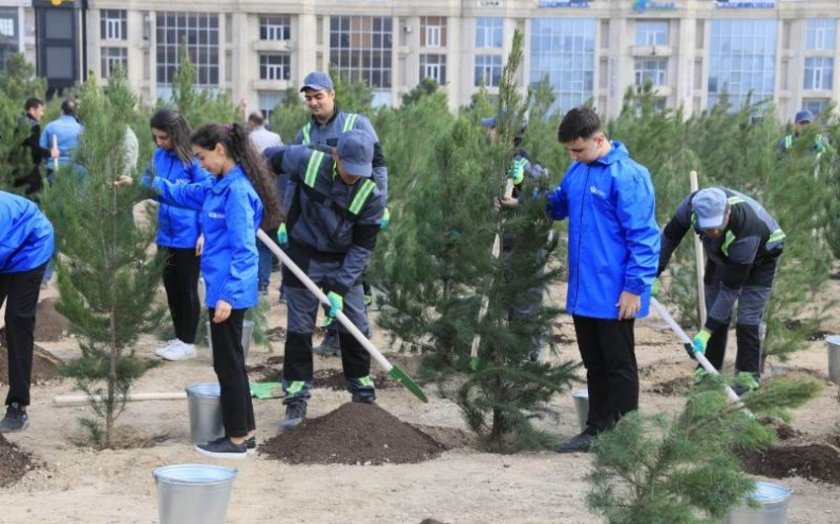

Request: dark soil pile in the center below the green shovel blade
left=258, top=402, right=444, bottom=465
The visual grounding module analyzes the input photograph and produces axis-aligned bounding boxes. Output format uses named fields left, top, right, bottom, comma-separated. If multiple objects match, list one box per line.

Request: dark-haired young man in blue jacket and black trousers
left=547, top=107, right=659, bottom=453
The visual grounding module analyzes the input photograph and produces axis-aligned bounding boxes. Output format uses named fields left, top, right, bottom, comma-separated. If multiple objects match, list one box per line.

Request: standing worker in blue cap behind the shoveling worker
left=288, top=71, right=390, bottom=355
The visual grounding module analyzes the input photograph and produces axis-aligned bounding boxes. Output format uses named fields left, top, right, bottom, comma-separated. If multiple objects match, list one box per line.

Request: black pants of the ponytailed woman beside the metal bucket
left=207, top=308, right=257, bottom=437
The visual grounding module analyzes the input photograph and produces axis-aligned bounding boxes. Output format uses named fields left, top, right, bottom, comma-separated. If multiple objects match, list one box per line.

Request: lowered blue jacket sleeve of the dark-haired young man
left=614, top=166, right=660, bottom=295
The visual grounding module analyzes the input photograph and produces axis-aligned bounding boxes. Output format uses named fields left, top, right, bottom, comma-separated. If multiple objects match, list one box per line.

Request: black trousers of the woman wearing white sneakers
left=163, top=247, right=201, bottom=344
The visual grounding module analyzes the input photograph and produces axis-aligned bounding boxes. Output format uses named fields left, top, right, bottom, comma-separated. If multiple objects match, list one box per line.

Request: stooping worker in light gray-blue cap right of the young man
left=654, top=187, right=785, bottom=395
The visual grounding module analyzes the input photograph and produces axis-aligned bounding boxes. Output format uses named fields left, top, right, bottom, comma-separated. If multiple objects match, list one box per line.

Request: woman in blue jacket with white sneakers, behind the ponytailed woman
left=146, top=109, right=209, bottom=360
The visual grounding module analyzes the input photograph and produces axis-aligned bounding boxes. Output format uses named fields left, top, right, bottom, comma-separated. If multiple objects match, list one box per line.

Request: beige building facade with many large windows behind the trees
left=0, top=0, right=840, bottom=120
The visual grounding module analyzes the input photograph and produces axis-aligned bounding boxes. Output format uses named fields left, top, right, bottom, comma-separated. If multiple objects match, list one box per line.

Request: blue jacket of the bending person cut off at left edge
left=0, top=191, right=55, bottom=273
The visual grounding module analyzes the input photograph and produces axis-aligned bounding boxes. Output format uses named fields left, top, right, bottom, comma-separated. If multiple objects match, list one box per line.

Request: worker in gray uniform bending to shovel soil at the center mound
left=270, top=129, right=385, bottom=430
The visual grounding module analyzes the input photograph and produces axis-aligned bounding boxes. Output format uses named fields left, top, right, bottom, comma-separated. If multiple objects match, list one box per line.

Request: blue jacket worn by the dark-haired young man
left=547, top=142, right=659, bottom=319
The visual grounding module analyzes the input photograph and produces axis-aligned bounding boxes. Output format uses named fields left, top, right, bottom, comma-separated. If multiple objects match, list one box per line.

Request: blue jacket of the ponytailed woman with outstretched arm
left=151, top=164, right=263, bottom=309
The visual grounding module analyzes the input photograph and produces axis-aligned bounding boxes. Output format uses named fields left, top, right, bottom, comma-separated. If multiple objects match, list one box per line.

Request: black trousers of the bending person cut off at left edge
left=0, top=263, right=47, bottom=406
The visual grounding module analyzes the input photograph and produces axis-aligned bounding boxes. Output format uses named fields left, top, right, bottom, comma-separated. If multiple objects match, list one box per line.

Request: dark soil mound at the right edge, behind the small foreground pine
left=741, top=443, right=840, bottom=484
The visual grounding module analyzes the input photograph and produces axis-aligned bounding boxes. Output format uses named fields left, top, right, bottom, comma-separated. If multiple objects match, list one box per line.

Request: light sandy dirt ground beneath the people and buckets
left=0, top=274, right=840, bottom=524
